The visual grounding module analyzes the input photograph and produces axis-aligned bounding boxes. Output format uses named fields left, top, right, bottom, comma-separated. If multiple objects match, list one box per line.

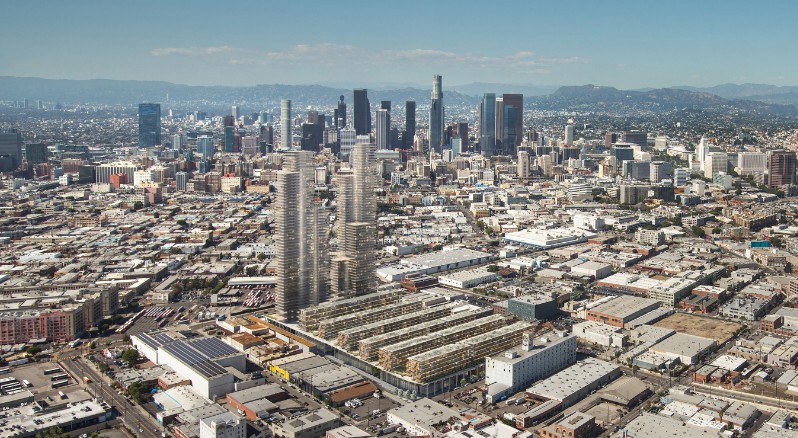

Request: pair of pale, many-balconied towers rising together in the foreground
left=274, top=143, right=377, bottom=322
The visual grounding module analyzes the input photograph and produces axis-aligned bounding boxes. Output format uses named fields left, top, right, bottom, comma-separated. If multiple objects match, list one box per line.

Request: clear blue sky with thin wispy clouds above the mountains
left=0, top=0, right=798, bottom=89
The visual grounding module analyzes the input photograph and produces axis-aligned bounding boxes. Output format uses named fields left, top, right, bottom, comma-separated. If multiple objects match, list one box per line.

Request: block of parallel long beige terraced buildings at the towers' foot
left=266, top=289, right=536, bottom=397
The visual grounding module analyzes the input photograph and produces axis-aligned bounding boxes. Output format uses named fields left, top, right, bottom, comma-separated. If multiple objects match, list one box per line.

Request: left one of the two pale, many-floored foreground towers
left=275, top=151, right=329, bottom=322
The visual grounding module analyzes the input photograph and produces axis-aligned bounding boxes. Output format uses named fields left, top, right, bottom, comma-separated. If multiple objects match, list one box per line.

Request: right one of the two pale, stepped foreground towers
left=330, top=143, right=377, bottom=297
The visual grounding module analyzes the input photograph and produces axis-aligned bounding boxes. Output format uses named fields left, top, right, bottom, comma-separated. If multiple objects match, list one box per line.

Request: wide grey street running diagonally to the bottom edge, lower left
left=62, top=357, right=165, bottom=438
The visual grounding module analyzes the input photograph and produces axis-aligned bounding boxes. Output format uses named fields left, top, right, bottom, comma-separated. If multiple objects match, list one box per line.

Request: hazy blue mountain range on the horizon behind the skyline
left=0, top=76, right=798, bottom=117
